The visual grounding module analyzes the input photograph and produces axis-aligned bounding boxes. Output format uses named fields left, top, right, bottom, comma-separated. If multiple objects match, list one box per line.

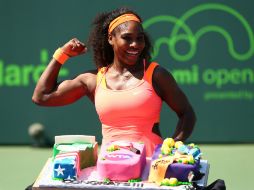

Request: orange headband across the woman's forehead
left=108, top=13, right=140, bottom=34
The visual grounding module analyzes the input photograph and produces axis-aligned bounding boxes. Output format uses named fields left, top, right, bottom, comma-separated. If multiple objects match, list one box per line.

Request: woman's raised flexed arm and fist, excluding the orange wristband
left=32, top=39, right=96, bottom=106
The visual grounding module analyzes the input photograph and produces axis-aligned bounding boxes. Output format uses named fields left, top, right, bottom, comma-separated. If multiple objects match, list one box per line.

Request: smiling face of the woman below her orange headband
left=108, top=21, right=145, bottom=65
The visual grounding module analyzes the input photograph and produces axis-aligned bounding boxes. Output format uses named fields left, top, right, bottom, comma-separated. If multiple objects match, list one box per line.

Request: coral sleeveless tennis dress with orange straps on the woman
left=95, top=62, right=162, bottom=156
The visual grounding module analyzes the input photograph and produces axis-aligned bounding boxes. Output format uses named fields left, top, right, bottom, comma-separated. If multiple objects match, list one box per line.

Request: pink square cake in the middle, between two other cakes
left=97, top=141, right=146, bottom=181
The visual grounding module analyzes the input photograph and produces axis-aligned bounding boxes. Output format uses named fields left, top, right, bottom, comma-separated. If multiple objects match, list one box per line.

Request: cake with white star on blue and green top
left=53, top=135, right=98, bottom=180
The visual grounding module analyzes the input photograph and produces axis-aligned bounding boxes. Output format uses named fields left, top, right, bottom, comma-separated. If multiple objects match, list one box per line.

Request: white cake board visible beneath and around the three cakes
left=32, top=158, right=209, bottom=190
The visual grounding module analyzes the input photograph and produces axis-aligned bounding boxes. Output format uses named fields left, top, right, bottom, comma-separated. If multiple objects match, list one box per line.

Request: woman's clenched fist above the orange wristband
left=62, top=38, right=87, bottom=57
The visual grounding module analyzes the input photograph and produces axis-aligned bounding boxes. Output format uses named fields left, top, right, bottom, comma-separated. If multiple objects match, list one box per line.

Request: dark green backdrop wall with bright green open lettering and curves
left=0, top=0, right=254, bottom=144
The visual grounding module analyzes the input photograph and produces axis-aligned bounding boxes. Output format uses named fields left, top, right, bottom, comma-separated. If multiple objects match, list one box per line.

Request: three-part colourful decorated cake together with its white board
left=32, top=135, right=205, bottom=190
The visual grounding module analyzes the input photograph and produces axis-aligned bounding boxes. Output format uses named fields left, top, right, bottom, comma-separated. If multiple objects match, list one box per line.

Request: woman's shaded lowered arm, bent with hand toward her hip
left=153, top=66, right=196, bottom=141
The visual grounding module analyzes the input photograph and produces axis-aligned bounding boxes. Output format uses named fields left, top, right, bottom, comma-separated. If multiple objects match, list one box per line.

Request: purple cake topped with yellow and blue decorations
left=148, top=138, right=201, bottom=186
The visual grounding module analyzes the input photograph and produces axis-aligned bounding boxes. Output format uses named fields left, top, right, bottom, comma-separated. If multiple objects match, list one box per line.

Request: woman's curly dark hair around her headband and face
left=88, top=7, right=152, bottom=68
